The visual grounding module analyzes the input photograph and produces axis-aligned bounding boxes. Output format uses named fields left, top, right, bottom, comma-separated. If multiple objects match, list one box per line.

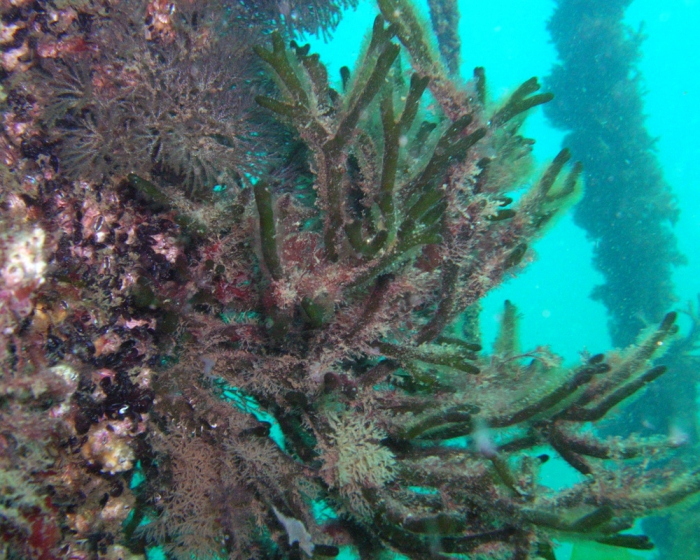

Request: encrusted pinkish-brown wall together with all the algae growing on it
left=0, top=0, right=700, bottom=560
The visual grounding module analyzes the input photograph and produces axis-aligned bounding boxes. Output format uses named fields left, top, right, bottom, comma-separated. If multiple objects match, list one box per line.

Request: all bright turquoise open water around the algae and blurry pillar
left=294, top=0, right=700, bottom=560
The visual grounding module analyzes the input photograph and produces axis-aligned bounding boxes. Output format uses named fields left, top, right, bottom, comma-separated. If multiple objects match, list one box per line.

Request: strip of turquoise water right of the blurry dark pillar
left=627, top=0, right=700, bottom=310
